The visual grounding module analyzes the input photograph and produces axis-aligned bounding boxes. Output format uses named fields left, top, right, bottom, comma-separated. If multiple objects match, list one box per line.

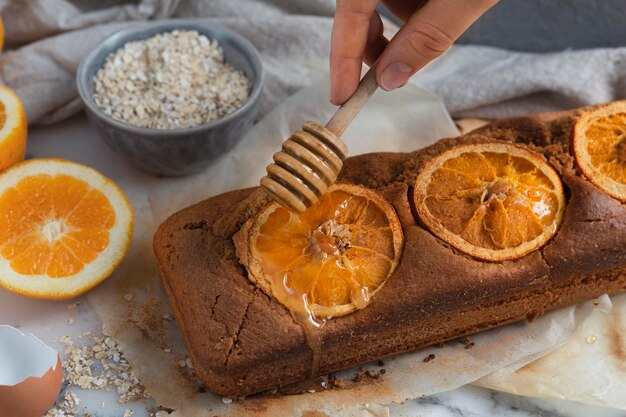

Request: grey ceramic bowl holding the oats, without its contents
left=76, top=20, right=264, bottom=176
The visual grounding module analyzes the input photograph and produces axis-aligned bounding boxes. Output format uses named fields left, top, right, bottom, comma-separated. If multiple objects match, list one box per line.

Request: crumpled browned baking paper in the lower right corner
left=475, top=294, right=626, bottom=410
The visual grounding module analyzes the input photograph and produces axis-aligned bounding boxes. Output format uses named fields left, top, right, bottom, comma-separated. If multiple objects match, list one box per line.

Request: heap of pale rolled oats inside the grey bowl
left=94, top=30, right=252, bottom=129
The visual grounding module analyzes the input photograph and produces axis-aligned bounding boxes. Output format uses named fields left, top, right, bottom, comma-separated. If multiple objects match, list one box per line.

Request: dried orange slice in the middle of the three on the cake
left=414, top=143, right=565, bottom=261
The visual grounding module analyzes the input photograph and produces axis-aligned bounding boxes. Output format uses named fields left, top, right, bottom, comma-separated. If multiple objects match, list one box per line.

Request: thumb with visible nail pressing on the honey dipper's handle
left=376, top=0, right=497, bottom=90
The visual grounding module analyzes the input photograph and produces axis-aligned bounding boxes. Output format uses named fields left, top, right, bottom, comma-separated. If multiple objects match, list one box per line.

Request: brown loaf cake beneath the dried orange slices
left=154, top=106, right=626, bottom=397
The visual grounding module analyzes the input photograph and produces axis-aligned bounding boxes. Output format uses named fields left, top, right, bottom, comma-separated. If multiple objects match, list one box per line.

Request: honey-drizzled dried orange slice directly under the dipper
left=235, top=184, right=404, bottom=318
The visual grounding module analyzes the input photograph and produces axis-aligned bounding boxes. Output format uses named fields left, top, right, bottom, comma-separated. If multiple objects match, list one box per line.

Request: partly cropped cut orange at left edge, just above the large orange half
left=0, top=86, right=27, bottom=171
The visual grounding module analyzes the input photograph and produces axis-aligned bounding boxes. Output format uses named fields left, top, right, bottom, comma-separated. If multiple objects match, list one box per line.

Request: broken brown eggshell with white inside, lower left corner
left=0, top=325, right=63, bottom=417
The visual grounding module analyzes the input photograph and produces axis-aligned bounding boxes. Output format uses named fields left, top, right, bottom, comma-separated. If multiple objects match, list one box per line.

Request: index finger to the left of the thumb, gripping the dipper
left=330, top=0, right=382, bottom=105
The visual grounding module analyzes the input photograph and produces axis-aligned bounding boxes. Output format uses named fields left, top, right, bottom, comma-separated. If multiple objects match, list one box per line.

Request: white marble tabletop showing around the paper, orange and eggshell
left=0, top=116, right=626, bottom=417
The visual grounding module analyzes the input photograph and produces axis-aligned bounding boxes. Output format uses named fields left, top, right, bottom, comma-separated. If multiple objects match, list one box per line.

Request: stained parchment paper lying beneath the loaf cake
left=89, top=74, right=610, bottom=417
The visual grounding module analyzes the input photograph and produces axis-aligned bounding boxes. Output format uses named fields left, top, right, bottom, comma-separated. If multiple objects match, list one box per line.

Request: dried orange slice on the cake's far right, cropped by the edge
left=573, top=101, right=626, bottom=202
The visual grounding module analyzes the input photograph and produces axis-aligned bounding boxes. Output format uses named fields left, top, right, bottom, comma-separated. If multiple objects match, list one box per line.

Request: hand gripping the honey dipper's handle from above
left=330, top=0, right=498, bottom=105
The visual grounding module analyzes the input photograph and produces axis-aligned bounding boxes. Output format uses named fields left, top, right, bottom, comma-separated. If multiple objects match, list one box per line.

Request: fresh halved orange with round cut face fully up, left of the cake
left=0, top=159, right=133, bottom=299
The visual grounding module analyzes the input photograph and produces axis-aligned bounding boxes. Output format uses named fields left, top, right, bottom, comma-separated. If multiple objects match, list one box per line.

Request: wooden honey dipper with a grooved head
left=261, top=68, right=378, bottom=213
